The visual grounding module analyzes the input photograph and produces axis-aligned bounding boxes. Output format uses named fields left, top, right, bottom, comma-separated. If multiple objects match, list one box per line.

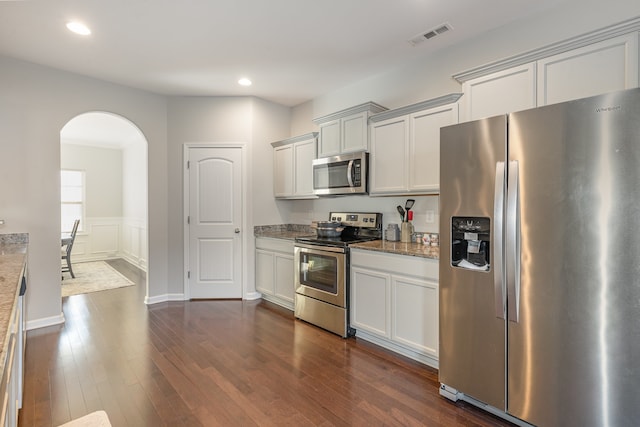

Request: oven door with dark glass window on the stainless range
left=294, top=243, right=347, bottom=307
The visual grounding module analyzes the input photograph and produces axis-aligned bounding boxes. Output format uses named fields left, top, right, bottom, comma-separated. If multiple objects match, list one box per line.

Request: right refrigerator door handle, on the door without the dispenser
left=506, top=160, right=520, bottom=323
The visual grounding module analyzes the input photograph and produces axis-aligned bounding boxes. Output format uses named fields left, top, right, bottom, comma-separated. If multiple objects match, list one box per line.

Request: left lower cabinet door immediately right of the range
left=351, top=266, right=391, bottom=338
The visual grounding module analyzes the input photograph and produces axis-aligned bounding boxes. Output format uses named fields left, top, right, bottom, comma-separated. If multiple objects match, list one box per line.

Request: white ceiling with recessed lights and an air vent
left=0, top=0, right=566, bottom=106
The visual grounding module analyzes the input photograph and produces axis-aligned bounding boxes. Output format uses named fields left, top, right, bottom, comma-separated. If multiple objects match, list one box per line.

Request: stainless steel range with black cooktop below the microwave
left=294, top=212, right=382, bottom=338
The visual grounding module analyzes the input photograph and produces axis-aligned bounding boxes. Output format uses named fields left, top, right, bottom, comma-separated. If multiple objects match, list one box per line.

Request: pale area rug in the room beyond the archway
left=62, top=261, right=134, bottom=297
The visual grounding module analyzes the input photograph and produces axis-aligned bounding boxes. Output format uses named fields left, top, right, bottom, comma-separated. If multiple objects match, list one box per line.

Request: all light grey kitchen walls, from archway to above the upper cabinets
left=0, top=0, right=640, bottom=324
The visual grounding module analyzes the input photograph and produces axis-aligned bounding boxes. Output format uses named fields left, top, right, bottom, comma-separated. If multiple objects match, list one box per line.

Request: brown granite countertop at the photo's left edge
left=0, top=234, right=28, bottom=382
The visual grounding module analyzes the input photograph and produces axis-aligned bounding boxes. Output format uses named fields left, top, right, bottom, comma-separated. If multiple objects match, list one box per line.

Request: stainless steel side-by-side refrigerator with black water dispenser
left=439, top=89, right=640, bottom=427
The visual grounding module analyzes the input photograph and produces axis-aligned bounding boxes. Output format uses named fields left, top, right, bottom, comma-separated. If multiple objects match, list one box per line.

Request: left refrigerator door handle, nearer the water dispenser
left=491, top=162, right=505, bottom=319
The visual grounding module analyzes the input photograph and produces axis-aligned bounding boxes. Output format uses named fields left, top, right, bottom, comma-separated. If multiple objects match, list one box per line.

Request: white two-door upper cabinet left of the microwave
left=271, top=132, right=318, bottom=199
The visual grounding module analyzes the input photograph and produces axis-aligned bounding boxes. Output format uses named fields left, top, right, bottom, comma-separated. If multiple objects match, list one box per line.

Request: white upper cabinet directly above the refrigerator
left=453, top=24, right=640, bottom=121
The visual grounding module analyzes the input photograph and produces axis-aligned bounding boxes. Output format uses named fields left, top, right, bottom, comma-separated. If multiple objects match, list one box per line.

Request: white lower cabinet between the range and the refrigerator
left=350, top=249, right=438, bottom=368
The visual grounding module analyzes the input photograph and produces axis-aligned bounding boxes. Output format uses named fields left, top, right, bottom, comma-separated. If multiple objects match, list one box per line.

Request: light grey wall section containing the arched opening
left=0, top=57, right=168, bottom=327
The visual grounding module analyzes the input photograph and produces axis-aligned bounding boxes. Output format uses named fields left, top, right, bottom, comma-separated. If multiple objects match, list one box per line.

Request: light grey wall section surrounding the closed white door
left=168, top=97, right=290, bottom=295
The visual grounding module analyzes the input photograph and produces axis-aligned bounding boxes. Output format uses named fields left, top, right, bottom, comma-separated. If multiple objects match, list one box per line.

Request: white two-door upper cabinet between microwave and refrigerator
left=369, top=94, right=461, bottom=195
